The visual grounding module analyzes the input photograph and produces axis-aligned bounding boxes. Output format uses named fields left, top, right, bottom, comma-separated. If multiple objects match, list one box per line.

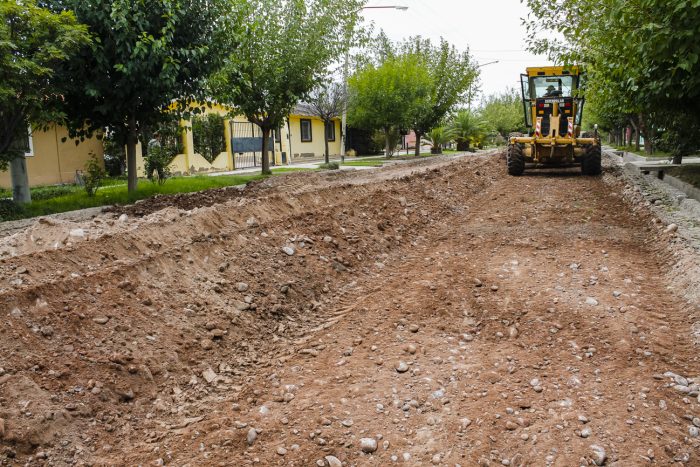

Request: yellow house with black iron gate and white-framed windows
left=136, top=103, right=341, bottom=177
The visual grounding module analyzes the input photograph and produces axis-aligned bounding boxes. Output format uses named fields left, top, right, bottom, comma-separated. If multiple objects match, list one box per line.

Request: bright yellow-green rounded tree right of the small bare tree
left=348, top=54, right=433, bottom=157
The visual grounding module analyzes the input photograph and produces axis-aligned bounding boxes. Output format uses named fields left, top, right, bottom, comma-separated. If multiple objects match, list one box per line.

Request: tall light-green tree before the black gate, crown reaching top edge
left=214, top=0, right=363, bottom=174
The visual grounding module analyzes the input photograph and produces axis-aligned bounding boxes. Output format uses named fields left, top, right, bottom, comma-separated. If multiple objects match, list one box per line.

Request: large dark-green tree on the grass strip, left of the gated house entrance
left=48, top=0, right=230, bottom=191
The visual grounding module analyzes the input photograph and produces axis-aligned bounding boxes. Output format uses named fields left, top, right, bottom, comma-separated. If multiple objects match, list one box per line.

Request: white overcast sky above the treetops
left=362, top=0, right=550, bottom=99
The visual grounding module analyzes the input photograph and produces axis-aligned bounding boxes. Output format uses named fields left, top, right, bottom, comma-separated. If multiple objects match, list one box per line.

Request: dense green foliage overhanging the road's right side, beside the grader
left=526, top=0, right=700, bottom=159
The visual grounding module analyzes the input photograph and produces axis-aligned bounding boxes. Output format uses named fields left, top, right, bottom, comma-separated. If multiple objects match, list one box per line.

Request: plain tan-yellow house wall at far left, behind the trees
left=0, top=125, right=104, bottom=188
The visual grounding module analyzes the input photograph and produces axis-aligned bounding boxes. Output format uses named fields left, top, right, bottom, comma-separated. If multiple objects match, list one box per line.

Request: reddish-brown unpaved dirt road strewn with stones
left=0, top=154, right=700, bottom=467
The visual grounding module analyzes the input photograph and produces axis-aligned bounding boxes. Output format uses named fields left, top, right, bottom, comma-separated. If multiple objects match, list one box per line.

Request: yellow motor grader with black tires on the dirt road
left=507, top=66, right=601, bottom=175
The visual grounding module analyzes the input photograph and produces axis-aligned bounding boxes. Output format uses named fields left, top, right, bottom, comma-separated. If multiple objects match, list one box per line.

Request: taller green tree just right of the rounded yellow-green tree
left=400, top=36, right=479, bottom=156
